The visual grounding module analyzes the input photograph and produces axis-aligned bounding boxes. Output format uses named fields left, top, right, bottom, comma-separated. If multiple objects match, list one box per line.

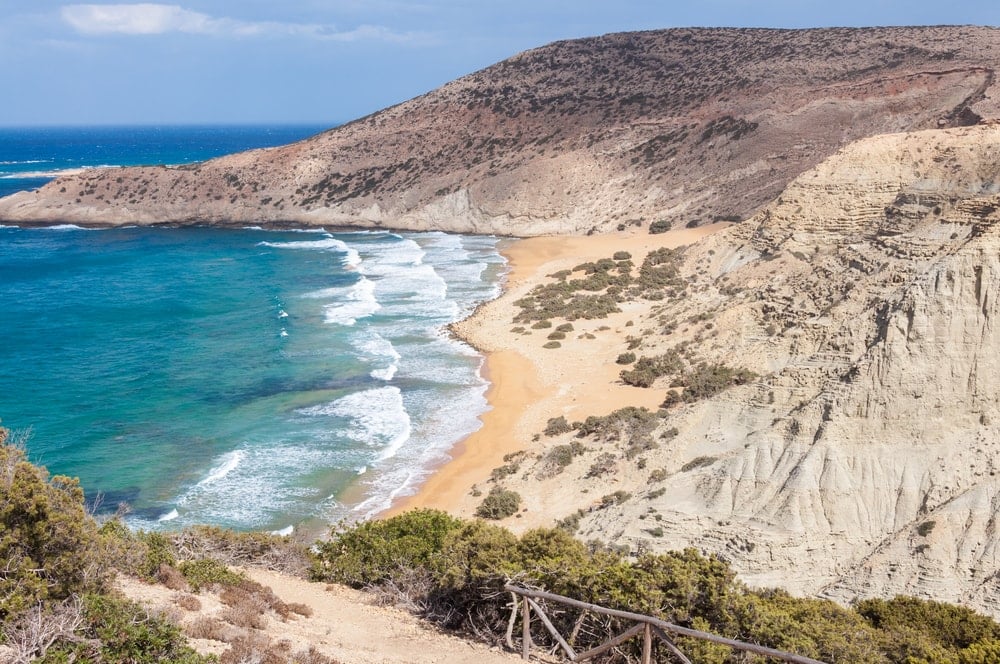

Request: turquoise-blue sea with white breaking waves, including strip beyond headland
left=0, top=127, right=506, bottom=533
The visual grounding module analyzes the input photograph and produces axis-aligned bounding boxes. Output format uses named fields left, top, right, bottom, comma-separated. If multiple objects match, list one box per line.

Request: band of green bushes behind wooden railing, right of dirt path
left=314, top=510, right=1000, bottom=664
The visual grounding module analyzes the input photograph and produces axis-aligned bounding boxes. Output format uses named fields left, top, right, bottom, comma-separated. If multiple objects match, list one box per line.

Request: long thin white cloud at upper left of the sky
left=60, top=3, right=426, bottom=43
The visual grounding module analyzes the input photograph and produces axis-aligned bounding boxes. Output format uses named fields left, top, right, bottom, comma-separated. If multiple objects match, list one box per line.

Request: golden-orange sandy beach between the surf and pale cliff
left=383, top=223, right=731, bottom=517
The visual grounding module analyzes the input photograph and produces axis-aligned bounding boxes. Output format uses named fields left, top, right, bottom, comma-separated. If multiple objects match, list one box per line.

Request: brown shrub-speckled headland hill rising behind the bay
left=0, top=27, right=1000, bottom=236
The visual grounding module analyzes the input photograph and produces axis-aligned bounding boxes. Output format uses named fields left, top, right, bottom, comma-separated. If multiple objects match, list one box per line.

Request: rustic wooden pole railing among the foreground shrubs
left=504, top=585, right=823, bottom=664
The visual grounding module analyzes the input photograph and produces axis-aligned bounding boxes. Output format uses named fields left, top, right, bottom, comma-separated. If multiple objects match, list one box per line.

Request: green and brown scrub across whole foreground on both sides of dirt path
left=9, top=420, right=1000, bottom=664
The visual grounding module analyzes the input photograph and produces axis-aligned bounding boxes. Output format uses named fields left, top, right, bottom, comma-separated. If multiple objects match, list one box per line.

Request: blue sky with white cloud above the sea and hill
left=0, top=0, right=1000, bottom=126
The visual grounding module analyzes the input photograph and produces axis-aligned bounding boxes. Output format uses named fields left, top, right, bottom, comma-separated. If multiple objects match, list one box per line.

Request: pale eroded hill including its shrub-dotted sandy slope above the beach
left=420, top=119, right=1000, bottom=616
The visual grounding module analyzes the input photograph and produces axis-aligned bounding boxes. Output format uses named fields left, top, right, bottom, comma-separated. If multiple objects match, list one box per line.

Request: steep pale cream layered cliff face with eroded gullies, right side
left=486, top=125, right=1000, bottom=616
